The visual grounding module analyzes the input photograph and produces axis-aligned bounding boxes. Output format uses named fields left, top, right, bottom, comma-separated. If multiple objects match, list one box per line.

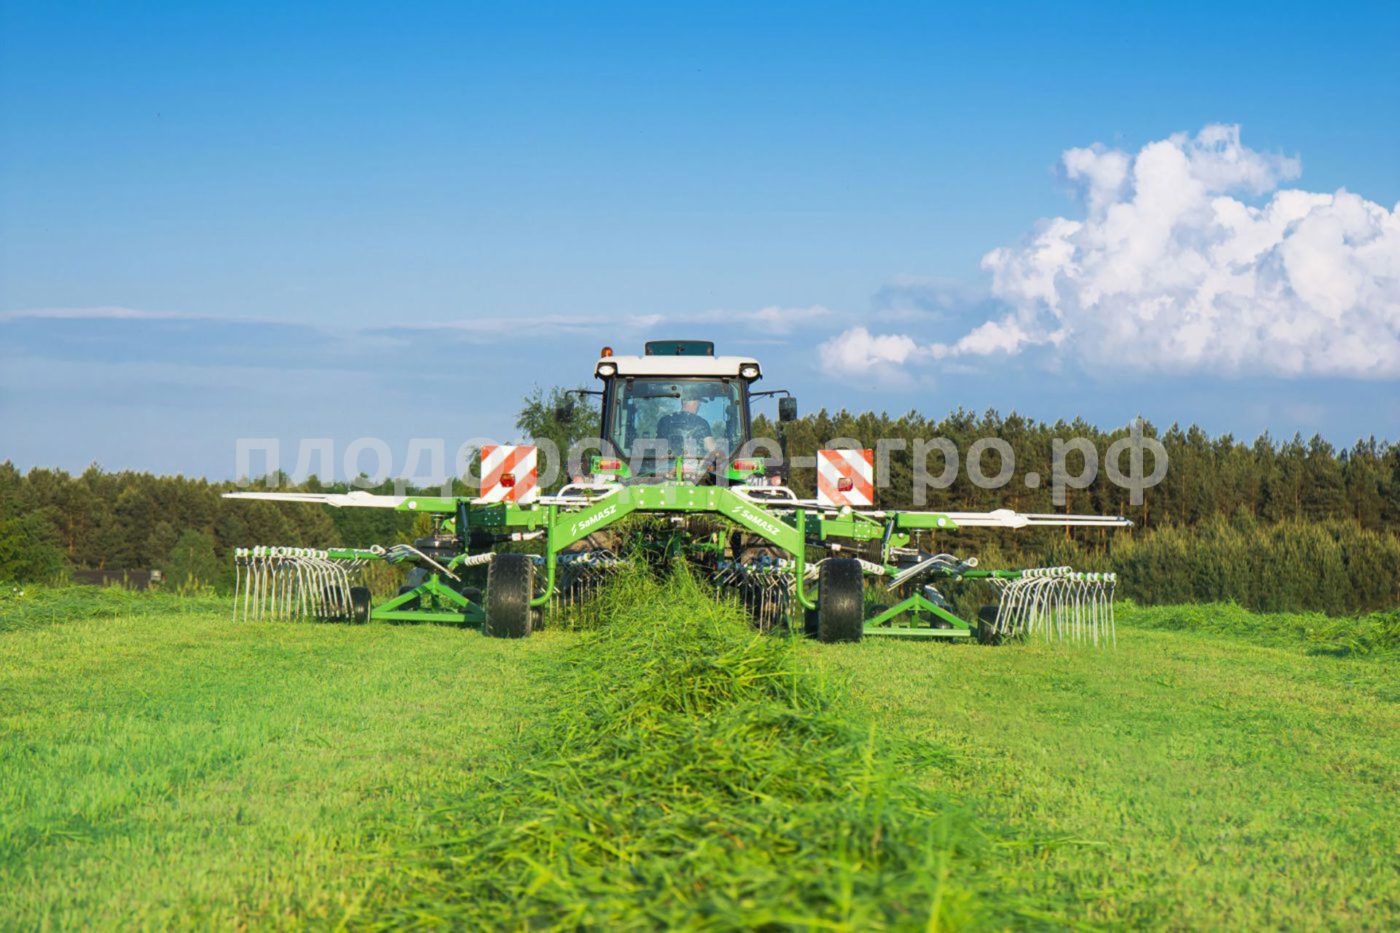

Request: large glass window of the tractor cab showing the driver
left=608, top=377, right=743, bottom=458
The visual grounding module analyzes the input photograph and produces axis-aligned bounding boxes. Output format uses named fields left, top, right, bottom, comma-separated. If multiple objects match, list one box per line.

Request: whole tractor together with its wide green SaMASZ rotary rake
left=227, top=340, right=1131, bottom=644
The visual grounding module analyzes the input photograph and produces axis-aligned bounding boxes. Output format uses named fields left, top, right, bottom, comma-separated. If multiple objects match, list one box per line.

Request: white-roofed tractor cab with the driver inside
left=592, top=340, right=795, bottom=482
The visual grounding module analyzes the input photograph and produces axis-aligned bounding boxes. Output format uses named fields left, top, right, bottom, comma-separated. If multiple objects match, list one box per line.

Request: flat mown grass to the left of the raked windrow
left=0, top=591, right=559, bottom=929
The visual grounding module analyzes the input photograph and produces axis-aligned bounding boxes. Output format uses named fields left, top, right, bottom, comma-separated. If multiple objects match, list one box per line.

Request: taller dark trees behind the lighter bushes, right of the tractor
left=755, top=409, right=1400, bottom=531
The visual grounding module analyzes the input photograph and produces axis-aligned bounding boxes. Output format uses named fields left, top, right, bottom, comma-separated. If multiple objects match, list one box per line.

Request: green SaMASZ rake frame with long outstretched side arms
left=227, top=482, right=1131, bottom=639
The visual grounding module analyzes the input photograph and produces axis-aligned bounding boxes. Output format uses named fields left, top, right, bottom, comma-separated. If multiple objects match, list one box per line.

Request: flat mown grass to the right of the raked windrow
left=804, top=614, right=1400, bottom=930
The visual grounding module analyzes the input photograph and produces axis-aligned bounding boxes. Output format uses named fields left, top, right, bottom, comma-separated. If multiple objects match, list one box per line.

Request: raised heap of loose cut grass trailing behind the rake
left=364, top=572, right=1058, bottom=929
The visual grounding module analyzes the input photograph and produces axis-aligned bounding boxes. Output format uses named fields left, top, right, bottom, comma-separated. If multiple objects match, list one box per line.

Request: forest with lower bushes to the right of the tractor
left=772, top=400, right=1400, bottom=614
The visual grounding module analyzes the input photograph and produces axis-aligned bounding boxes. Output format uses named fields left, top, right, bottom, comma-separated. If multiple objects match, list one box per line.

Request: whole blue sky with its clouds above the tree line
left=0, top=3, right=1400, bottom=476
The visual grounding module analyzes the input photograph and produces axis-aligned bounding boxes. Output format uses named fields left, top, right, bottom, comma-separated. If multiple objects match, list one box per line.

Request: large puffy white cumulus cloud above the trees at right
left=833, top=126, right=1400, bottom=378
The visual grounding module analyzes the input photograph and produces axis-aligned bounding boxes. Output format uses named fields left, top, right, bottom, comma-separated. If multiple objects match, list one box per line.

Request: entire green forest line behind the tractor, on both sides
left=0, top=388, right=1400, bottom=612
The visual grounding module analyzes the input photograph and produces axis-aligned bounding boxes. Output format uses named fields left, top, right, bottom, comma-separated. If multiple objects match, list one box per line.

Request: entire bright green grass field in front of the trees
left=0, top=591, right=1400, bottom=930
